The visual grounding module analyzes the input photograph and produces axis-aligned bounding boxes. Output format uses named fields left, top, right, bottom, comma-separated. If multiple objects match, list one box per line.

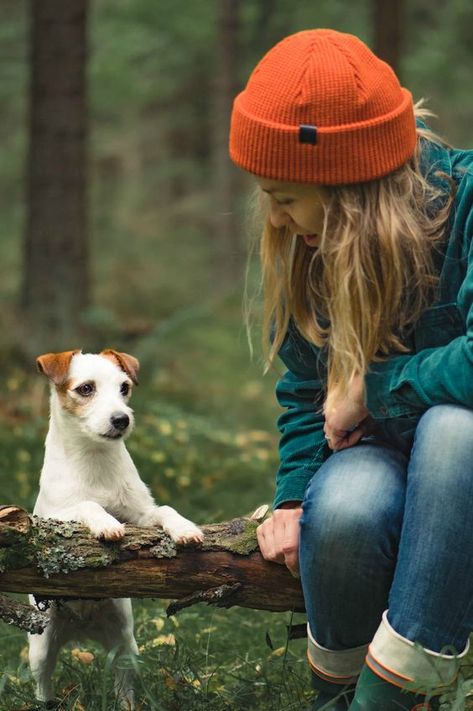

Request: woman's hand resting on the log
left=256, top=501, right=302, bottom=578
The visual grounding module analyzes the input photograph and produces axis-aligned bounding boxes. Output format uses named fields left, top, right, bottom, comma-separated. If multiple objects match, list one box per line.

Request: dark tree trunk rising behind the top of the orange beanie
left=373, top=0, right=405, bottom=76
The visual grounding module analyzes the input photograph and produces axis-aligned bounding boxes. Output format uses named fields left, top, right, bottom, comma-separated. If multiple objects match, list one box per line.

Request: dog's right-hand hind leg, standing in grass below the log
left=94, top=598, right=138, bottom=711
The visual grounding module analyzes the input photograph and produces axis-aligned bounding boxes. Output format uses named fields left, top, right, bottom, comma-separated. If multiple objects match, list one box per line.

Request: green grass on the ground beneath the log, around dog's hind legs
left=0, top=600, right=310, bottom=711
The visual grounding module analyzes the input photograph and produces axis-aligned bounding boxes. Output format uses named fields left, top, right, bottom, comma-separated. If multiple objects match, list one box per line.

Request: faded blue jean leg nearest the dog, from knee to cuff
left=300, top=442, right=407, bottom=649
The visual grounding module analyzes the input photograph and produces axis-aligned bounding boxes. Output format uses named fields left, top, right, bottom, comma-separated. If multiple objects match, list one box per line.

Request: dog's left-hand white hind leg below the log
left=28, top=621, right=61, bottom=701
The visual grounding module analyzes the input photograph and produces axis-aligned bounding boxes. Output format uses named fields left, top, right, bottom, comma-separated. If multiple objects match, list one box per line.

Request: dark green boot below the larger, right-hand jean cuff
left=348, top=664, right=439, bottom=711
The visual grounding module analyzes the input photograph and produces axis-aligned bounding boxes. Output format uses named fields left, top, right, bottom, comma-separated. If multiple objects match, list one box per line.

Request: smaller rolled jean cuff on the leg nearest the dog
left=307, top=625, right=368, bottom=686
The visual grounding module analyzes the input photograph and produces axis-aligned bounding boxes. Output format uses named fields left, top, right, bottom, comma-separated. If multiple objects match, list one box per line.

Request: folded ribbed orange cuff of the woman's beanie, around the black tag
left=230, top=87, right=417, bottom=185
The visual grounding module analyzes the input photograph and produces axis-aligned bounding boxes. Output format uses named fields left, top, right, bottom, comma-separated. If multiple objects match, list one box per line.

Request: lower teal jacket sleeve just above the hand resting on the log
left=273, top=371, right=330, bottom=508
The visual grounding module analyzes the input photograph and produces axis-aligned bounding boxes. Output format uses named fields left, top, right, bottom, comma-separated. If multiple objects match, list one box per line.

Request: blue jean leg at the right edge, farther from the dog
left=389, top=405, right=473, bottom=651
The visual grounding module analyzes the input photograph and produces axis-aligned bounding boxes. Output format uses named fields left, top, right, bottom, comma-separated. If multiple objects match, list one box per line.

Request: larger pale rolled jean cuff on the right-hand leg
left=366, top=610, right=469, bottom=691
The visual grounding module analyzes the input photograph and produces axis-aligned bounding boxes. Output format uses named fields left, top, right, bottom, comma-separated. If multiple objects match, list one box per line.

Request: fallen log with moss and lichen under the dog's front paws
left=0, top=506, right=304, bottom=624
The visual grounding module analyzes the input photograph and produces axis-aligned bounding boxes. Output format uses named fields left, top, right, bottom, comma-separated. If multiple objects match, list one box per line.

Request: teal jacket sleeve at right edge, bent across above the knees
left=365, top=175, right=473, bottom=419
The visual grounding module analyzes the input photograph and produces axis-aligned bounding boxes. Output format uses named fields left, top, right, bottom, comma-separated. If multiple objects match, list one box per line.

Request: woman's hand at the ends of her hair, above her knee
left=324, top=375, right=369, bottom=451
